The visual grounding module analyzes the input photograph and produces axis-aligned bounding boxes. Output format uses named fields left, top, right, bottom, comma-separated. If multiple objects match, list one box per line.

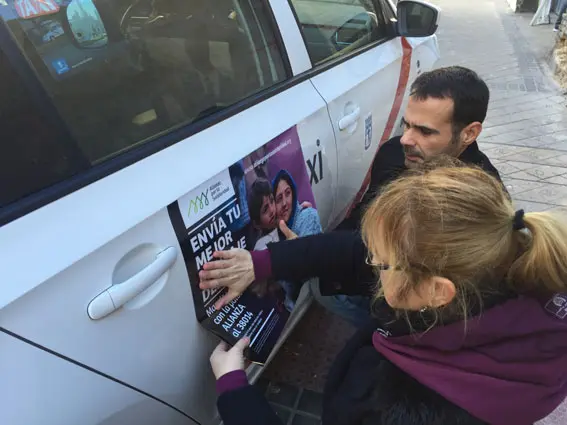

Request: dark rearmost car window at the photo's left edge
left=0, top=44, right=85, bottom=211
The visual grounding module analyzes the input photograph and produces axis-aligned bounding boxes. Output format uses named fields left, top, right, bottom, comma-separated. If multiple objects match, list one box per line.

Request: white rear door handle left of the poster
left=87, top=246, right=177, bottom=320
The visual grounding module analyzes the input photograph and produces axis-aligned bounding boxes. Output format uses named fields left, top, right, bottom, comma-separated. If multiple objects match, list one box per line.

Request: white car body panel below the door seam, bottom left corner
left=0, top=332, right=197, bottom=425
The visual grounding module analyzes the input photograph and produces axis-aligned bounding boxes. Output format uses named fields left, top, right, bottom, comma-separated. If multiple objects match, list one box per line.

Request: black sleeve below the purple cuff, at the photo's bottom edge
left=217, top=385, right=283, bottom=425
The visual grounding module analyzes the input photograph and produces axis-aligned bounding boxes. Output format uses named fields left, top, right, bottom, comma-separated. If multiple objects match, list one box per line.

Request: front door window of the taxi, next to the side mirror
left=291, top=0, right=388, bottom=64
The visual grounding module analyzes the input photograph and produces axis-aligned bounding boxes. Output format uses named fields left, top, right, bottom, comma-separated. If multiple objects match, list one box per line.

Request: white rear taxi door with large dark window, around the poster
left=0, top=0, right=337, bottom=425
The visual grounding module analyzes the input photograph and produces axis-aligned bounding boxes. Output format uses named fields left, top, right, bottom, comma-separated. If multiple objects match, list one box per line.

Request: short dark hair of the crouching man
left=410, top=66, right=490, bottom=134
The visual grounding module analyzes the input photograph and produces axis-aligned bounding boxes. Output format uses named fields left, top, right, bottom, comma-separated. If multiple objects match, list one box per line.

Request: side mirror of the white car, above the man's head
left=396, top=0, right=440, bottom=37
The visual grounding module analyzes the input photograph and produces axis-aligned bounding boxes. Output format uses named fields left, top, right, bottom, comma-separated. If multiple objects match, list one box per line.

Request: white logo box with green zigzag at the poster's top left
left=179, top=170, right=235, bottom=228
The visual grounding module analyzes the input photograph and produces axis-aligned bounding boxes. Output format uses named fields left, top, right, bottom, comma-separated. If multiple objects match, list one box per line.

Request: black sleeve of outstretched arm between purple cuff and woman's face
left=268, top=231, right=376, bottom=296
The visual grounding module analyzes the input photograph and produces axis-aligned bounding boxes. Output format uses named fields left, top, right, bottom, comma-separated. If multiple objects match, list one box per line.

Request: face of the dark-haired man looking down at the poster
left=401, top=97, right=464, bottom=168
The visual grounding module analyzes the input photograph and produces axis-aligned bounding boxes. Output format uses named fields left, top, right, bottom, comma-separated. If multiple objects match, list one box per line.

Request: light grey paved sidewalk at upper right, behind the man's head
left=434, top=0, right=567, bottom=212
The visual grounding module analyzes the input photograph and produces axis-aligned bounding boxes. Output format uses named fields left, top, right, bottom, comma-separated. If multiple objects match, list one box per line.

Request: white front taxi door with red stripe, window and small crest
left=291, top=0, right=440, bottom=223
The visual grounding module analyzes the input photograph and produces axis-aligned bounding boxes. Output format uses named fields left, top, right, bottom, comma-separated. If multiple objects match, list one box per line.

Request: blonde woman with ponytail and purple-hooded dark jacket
left=203, top=158, right=567, bottom=425
